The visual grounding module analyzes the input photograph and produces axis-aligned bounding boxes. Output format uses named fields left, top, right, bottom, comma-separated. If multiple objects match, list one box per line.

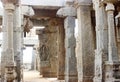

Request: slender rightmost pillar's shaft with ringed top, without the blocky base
left=106, top=3, right=118, bottom=61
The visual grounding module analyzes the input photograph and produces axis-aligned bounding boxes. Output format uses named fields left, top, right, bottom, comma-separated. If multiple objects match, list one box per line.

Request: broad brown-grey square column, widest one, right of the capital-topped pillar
left=76, top=0, right=95, bottom=82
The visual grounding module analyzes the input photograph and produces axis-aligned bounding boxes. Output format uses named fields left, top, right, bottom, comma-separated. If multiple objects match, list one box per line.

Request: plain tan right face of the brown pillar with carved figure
left=46, top=18, right=58, bottom=77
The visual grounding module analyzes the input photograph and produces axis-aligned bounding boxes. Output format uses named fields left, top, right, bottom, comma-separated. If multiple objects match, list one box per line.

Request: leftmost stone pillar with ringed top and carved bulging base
left=1, top=0, right=17, bottom=82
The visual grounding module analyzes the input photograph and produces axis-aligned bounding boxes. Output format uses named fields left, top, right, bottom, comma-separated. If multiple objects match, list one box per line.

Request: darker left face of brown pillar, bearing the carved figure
left=36, top=28, right=50, bottom=77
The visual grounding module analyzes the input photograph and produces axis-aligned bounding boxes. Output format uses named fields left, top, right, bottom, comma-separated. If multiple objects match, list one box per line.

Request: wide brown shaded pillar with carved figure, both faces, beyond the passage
left=36, top=22, right=58, bottom=77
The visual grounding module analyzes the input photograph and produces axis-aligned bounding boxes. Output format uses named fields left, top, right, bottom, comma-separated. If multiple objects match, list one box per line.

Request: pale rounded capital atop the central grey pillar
left=57, top=6, right=77, bottom=18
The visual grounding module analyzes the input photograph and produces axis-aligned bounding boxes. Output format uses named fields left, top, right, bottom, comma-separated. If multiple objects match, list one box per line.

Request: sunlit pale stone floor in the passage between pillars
left=24, top=71, right=64, bottom=82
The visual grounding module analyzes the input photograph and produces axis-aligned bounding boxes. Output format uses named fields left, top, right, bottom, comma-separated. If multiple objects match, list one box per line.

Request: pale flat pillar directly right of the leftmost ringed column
left=13, top=1, right=23, bottom=82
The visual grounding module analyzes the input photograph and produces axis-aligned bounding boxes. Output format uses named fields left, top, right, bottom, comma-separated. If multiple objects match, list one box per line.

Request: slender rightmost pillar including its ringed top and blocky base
left=104, top=0, right=120, bottom=82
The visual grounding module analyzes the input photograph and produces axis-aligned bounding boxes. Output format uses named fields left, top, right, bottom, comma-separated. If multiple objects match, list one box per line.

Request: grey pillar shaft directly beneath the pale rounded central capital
left=64, top=16, right=78, bottom=82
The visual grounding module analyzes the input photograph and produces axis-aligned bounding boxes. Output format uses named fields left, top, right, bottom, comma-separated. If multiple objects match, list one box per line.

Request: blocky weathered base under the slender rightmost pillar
left=105, top=61, right=120, bottom=82
